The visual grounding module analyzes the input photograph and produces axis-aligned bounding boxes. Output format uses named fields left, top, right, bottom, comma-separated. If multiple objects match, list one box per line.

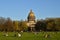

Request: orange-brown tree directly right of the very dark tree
left=46, top=18, right=56, bottom=31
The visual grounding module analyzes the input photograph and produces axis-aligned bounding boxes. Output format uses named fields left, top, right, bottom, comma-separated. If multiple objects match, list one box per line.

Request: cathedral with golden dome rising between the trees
left=27, top=10, right=36, bottom=31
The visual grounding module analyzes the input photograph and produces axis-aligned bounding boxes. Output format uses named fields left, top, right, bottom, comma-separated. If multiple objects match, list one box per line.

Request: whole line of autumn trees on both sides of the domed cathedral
left=0, top=17, right=60, bottom=31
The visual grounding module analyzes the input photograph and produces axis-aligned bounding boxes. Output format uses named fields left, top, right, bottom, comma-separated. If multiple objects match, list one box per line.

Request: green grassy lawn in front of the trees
left=0, top=32, right=60, bottom=40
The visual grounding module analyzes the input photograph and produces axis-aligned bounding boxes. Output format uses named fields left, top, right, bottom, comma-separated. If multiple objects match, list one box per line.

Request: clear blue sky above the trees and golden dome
left=0, top=0, right=60, bottom=20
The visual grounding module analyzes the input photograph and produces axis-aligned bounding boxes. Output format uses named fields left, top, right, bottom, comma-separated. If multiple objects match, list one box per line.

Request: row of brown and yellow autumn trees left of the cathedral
left=0, top=17, right=27, bottom=31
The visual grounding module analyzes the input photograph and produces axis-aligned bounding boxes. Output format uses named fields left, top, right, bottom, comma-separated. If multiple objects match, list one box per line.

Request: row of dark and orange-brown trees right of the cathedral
left=35, top=18, right=60, bottom=31
